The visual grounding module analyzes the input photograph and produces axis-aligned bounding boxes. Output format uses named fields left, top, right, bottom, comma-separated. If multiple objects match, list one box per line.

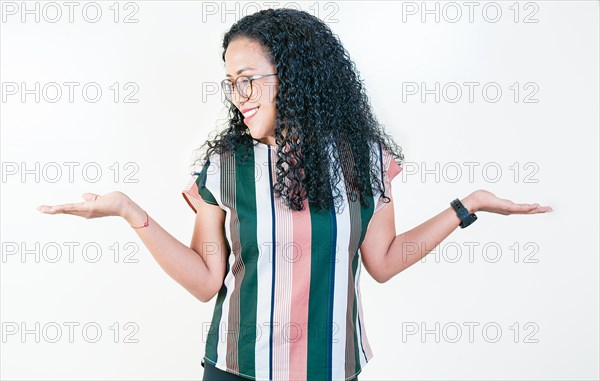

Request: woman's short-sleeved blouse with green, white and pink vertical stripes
left=182, top=140, right=402, bottom=380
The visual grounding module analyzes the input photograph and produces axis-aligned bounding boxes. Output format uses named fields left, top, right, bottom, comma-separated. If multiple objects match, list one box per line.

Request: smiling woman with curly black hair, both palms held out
left=40, top=9, right=551, bottom=380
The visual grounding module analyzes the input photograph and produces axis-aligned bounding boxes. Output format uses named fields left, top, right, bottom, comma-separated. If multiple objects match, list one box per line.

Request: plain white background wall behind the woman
left=0, top=1, right=599, bottom=380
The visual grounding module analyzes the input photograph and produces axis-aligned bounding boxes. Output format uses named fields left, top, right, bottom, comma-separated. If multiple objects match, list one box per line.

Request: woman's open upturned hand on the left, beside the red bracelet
left=37, top=191, right=131, bottom=218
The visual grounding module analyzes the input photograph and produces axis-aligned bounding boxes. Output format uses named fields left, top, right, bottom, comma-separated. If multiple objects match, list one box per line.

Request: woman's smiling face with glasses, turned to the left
left=225, top=37, right=279, bottom=146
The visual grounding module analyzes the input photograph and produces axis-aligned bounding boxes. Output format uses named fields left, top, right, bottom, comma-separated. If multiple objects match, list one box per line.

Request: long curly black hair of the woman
left=191, top=8, right=404, bottom=214
